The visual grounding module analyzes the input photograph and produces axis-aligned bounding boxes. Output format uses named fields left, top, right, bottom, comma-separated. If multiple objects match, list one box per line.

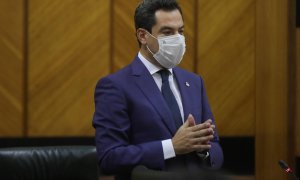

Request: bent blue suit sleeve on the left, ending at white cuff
left=93, top=78, right=164, bottom=174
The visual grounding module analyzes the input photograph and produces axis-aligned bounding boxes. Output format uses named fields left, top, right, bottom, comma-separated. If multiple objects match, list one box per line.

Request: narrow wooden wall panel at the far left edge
left=0, top=0, right=25, bottom=137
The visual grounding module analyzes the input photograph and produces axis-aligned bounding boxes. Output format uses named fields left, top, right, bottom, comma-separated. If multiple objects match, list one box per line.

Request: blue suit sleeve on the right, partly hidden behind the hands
left=200, top=77, right=223, bottom=169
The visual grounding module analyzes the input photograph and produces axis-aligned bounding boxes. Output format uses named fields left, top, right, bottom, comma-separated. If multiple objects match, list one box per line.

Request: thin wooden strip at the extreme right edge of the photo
left=295, top=28, right=300, bottom=157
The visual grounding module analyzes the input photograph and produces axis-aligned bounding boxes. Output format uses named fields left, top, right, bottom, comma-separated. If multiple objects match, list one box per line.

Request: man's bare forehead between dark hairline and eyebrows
left=154, top=9, right=183, bottom=29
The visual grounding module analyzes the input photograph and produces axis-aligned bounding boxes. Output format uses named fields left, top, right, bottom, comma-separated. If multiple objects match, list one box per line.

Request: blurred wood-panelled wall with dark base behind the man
left=0, top=0, right=300, bottom=180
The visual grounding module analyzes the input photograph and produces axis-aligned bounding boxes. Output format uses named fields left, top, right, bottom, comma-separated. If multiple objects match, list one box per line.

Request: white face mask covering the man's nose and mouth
left=147, top=33, right=186, bottom=69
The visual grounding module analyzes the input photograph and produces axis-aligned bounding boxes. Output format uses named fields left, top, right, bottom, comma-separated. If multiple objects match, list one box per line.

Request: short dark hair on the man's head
left=134, top=0, right=182, bottom=33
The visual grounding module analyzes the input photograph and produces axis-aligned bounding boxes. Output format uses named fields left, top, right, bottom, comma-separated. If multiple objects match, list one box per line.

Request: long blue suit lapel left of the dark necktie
left=132, top=57, right=176, bottom=135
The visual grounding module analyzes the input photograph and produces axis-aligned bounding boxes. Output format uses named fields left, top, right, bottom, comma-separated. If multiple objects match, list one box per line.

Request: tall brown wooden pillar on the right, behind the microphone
left=255, top=0, right=293, bottom=180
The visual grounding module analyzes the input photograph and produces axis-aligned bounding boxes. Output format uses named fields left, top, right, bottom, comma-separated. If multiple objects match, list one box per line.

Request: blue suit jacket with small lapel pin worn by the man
left=93, top=57, right=223, bottom=179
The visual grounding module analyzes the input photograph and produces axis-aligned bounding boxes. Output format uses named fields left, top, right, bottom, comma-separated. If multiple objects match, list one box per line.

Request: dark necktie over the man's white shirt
left=158, top=69, right=182, bottom=129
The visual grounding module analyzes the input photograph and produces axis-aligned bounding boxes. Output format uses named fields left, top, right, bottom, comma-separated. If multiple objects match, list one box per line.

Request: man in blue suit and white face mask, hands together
left=93, top=0, right=223, bottom=179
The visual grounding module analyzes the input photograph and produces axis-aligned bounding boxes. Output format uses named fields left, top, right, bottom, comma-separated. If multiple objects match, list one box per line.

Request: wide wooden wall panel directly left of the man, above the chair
left=28, top=0, right=110, bottom=136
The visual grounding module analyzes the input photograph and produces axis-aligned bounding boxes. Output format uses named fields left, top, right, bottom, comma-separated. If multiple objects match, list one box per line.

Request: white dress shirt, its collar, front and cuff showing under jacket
left=138, top=52, right=184, bottom=159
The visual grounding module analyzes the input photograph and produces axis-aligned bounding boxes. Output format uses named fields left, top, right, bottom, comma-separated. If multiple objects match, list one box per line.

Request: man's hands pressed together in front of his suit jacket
left=172, top=114, right=215, bottom=154
